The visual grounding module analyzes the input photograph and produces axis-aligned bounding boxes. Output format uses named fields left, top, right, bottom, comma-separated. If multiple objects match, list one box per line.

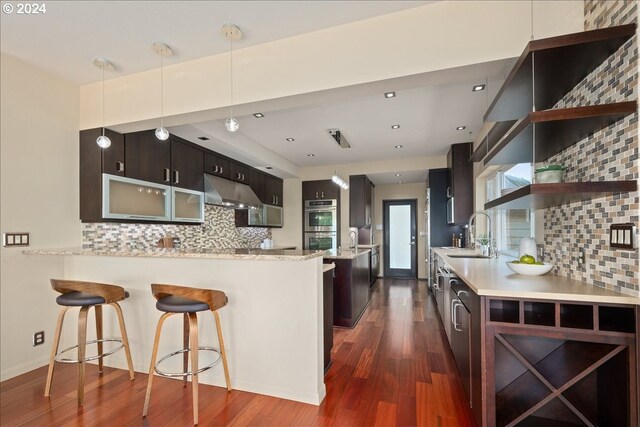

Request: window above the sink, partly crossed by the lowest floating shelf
left=487, top=163, right=534, bottom=257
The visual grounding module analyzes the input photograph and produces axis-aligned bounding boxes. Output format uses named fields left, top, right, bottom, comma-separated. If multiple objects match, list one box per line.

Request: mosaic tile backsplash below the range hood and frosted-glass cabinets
left=82, top=205, right=271, bottom=250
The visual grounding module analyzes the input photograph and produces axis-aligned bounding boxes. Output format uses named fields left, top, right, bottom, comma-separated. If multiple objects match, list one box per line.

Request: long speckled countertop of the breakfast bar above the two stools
left=22, top=248, right=324, bottom=261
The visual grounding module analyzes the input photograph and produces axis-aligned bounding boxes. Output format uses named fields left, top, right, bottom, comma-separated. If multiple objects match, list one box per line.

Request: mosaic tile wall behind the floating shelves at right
left=544, top=0, right=640, bottom=296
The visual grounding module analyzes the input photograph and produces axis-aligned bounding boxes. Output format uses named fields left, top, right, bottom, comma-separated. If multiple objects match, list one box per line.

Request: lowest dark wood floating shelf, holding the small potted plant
left=484, top=181, right=638, bottom=209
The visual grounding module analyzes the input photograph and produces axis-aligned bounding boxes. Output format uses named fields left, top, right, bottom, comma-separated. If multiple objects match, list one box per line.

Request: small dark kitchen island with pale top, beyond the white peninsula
left=324, top=249, right=371, bottom=328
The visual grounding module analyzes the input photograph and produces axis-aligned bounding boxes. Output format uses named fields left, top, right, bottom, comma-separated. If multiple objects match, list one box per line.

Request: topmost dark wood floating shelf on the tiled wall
left=484, top=24, right=636, bottom=122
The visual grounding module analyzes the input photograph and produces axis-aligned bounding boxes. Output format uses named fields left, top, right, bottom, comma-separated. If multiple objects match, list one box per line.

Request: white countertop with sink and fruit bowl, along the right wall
left=433, top=248, right=640, bottom=305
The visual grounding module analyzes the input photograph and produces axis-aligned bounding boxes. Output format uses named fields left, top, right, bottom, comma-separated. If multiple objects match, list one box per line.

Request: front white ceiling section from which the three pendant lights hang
left=0, top=0, right=433, bottom=84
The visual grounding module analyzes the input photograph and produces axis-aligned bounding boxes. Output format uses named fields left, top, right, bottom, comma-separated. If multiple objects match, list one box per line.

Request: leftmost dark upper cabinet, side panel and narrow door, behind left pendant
left=80, top=128, right=126, bottom=222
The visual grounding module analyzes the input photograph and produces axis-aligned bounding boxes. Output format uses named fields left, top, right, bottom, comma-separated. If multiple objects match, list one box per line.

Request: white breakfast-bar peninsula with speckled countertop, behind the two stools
left=24, top=248, right=325, bottom=405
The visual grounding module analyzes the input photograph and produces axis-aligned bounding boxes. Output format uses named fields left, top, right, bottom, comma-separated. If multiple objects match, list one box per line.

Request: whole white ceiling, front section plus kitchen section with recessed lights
left=0, top=1, right=512, bottom=184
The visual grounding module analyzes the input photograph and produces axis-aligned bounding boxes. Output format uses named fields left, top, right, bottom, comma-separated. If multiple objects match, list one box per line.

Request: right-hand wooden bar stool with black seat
left=142, top=283, right=231, bottom=425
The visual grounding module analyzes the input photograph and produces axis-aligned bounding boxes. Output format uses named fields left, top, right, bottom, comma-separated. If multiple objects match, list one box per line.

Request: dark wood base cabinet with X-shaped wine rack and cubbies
left=484, top=298, right=638, bottom=427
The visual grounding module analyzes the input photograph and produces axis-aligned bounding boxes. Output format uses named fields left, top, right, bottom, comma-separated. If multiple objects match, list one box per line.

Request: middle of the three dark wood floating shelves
left=484, top=101, right=638, bottom=165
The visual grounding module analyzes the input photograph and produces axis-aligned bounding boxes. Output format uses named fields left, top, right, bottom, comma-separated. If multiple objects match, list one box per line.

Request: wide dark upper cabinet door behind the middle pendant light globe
left=125, top=129, right=171, bottom=185
